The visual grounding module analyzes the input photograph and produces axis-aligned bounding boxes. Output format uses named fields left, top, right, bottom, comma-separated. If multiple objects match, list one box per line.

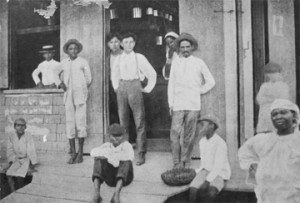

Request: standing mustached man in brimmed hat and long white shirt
left=168, top=33, right=215, bottom=167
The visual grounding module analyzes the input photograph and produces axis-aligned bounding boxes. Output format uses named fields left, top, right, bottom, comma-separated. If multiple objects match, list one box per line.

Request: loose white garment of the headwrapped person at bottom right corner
left=238, top=130, right=300, bottom=203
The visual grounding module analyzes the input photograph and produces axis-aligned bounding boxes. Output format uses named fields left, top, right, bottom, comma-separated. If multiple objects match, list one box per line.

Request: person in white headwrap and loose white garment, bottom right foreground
left=238, top=99, right=300, bottom=203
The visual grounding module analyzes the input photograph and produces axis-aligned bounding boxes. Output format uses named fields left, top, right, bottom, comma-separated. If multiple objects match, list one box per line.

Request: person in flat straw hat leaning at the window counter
left=32, top=45, right=62, bottom=88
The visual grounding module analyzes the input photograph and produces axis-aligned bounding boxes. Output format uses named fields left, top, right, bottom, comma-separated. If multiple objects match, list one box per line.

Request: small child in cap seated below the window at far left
left=5, top=118, right=37, bottom=192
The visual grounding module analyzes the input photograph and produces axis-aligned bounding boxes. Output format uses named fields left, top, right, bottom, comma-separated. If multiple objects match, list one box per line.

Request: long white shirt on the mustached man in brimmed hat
left=168, top=56, right=215, bottom=111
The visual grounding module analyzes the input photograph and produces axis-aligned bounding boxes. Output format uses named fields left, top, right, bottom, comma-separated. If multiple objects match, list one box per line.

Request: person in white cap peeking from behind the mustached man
left=162, top=31, right=178, bottom=80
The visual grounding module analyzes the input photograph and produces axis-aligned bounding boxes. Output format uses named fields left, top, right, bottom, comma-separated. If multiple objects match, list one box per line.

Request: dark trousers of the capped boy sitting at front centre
left=92, top=157, right=133, bottom=187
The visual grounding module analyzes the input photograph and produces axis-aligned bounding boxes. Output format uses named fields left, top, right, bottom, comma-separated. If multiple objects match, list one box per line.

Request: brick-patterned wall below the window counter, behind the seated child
left=0, top=90, right=69, bottom=158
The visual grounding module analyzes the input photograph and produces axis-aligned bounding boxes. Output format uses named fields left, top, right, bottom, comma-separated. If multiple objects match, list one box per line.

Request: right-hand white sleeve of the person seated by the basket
left=206, top=143, right=227, bottom=182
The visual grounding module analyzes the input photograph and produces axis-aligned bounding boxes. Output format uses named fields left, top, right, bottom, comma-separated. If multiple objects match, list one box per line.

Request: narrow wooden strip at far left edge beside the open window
left=0, top=0, right=8, bottom=88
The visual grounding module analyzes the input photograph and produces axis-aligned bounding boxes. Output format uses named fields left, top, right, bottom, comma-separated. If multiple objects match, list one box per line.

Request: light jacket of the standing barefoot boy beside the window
left=61, top=56, right=92, bottom=105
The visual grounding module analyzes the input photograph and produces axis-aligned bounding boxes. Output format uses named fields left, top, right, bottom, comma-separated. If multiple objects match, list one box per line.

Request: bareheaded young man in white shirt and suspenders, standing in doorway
left=111, top=33, right=156, bottom=165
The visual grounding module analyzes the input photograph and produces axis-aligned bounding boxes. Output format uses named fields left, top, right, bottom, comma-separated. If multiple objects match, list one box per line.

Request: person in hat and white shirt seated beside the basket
left=190, top=115, right=231, bottom=202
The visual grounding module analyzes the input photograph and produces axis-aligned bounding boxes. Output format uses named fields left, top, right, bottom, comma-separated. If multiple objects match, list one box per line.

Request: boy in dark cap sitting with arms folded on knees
left=91, top=124, right=134, bottom=203
